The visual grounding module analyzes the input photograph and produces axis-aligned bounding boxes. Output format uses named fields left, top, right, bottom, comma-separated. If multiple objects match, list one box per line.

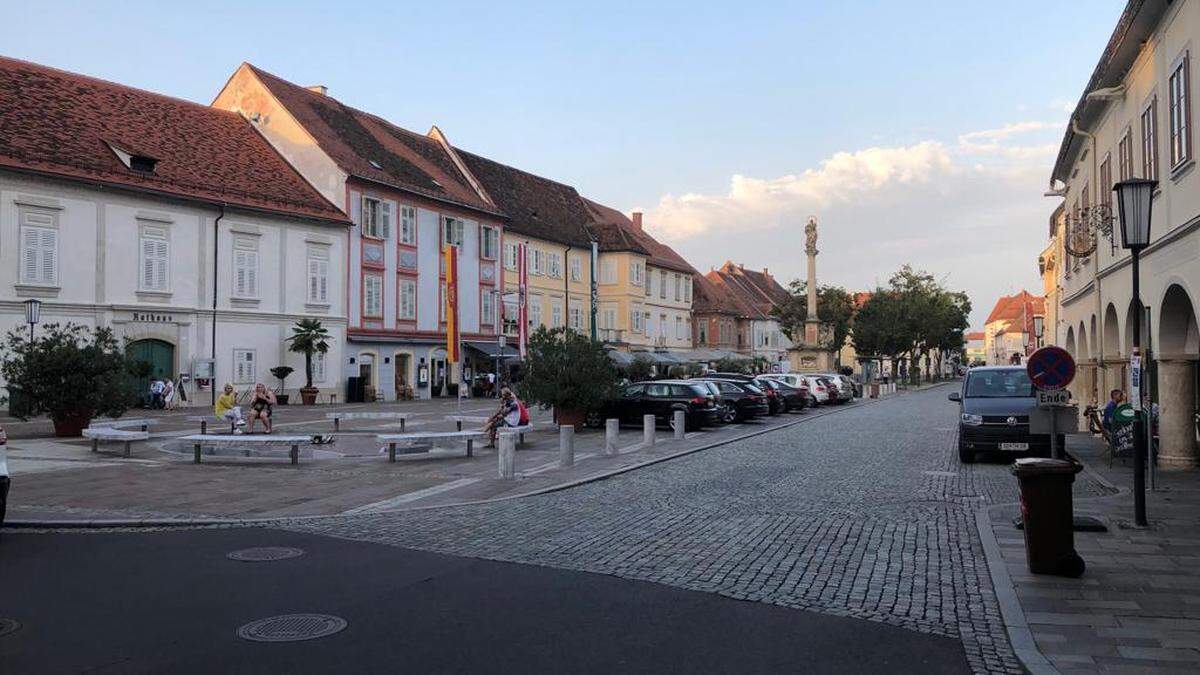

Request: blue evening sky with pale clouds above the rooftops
left=0, top=0, right=1124, bottom=327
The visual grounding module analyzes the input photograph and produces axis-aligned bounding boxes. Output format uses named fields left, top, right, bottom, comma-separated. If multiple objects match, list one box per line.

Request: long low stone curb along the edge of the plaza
left=0, top=381, right=953, bottom=530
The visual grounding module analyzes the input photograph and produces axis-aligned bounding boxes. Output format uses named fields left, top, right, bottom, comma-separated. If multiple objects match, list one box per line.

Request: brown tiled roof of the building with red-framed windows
left=244, top=64, right=502, bottom=215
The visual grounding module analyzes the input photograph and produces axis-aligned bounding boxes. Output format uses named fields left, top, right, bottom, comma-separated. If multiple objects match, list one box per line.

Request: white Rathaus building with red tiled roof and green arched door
left=0, top=59, right=349, bottom=405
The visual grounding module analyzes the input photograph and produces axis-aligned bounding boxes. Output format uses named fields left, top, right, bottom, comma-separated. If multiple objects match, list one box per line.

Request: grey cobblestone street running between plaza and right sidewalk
left=281, top=387, right=1104, bottom=673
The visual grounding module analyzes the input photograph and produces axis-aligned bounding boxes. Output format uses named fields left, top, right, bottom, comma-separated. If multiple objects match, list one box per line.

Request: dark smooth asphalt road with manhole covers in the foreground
left=0, top=528, right=967, bottom=674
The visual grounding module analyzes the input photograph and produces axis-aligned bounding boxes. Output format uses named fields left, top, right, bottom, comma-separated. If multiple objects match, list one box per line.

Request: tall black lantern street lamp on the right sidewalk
left=1112, top=178, right=1158, bottom=526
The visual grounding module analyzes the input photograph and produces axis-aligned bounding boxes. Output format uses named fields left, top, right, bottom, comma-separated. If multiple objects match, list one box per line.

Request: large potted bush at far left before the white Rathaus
left=0, top=323, right=134, bottom=437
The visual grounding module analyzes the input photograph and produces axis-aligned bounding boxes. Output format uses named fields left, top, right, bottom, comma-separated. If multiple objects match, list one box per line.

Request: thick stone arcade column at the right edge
left=1158, top=358, right=1200, bottom=468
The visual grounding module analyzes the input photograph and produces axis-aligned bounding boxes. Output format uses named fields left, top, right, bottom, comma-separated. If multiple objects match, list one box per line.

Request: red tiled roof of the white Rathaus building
left=0, top=56, right=348, bottom=223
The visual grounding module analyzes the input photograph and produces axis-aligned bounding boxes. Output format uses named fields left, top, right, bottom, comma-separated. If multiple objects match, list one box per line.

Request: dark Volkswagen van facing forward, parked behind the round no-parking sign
left=949, top=366, right=1062, bottom=464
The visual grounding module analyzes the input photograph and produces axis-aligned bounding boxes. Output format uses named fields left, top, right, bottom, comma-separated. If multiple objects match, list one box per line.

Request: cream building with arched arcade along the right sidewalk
left=1051, top=0, right=1200, bottom=467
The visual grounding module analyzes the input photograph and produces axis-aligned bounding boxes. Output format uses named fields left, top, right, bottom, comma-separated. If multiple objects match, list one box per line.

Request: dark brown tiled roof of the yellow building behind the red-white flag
left=455, top=148, right=593, bottom=247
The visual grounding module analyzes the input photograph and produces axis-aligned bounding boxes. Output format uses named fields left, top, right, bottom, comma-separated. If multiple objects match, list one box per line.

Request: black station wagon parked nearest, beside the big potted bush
left=584, top=380, right=721, bottom=431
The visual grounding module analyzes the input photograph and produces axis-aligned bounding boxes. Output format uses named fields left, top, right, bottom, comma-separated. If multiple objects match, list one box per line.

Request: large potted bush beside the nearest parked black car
left=517, top=327, right=617, bottom=428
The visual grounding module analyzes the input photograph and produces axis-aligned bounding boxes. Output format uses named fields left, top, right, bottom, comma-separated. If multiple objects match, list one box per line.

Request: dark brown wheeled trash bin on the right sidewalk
left=1013, top=458, right=1084, bottom=578
